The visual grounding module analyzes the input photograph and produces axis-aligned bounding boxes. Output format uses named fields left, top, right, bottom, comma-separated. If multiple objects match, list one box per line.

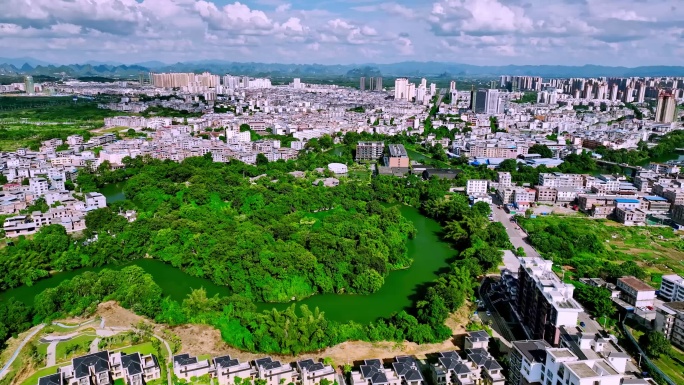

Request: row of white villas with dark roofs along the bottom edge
left=38, top=331, right=505, bottom=385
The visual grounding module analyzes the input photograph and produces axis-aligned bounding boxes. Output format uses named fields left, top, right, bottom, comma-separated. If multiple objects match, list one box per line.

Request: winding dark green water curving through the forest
left=0, top=184, right=455, bottom=323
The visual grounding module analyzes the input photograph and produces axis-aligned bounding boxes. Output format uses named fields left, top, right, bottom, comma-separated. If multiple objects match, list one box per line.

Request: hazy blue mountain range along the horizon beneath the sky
left=0, top=57, right=684, bottom=79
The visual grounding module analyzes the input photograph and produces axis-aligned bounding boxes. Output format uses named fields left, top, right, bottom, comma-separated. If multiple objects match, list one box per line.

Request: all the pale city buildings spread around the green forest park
left=0, top=73, right=684, bottom=385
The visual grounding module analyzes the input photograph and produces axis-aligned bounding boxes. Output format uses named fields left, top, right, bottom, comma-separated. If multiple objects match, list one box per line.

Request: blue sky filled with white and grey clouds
left=0, top=0, right=684, bottom=67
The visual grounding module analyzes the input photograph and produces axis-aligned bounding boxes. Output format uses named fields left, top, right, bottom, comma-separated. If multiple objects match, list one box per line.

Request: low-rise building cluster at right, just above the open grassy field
left=466, top=163, right=684, bottom=226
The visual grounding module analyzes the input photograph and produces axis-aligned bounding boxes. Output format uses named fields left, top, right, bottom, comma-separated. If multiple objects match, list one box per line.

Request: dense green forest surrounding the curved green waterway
left=0, top=148, right=510, bottom=354
